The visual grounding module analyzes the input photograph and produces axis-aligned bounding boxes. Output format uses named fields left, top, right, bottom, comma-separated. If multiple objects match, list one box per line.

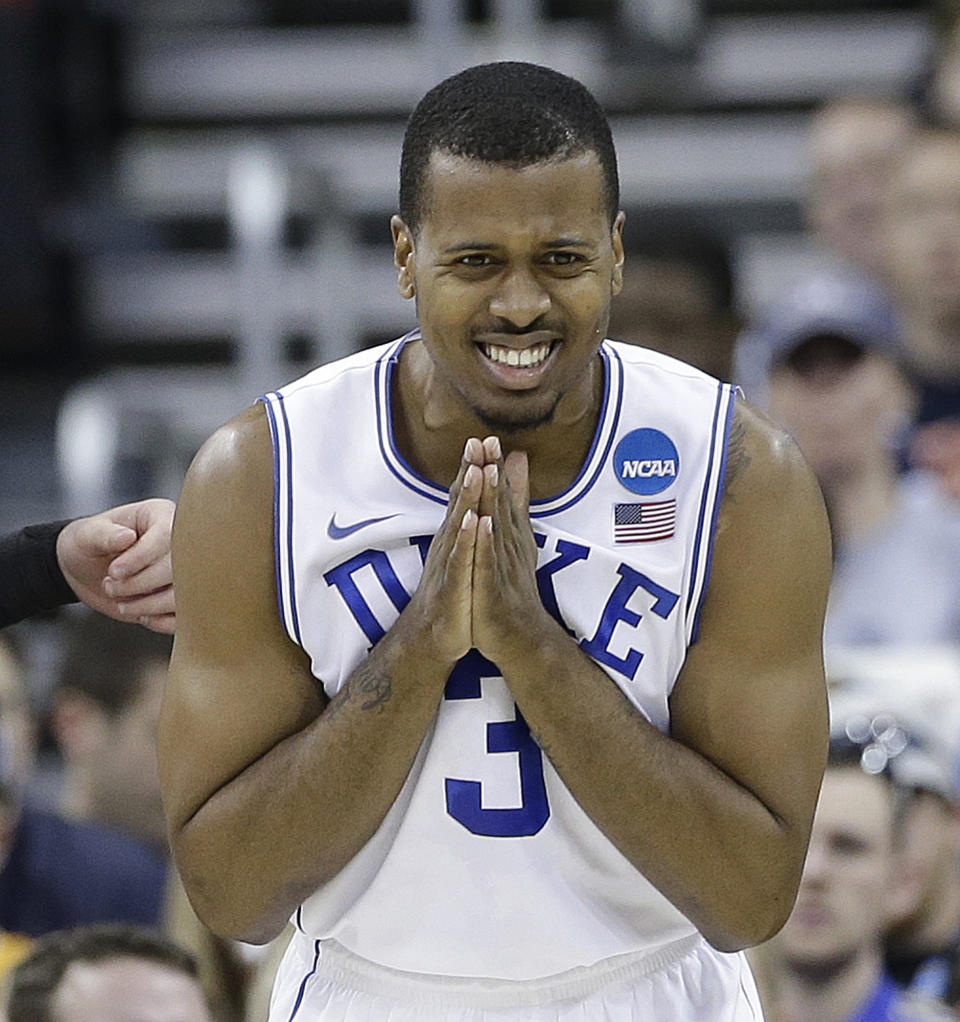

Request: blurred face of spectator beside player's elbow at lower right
left=776, top=767, right=898, bottom=970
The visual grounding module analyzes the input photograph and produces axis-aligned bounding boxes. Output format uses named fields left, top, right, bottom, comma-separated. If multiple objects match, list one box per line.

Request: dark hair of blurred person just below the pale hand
left=58, top=609, right=173, bottom=716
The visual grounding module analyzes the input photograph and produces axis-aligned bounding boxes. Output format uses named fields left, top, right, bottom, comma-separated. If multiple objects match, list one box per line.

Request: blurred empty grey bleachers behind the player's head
left=0, top=0, right=951, bottom=529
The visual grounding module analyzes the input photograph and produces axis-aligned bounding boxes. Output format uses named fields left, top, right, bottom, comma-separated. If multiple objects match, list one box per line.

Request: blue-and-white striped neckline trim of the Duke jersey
left=373, top=330, right=624, bottom=518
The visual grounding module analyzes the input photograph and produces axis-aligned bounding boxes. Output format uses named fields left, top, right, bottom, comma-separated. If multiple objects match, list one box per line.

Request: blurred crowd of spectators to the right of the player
left=611, top=9, right=960, bottom=1022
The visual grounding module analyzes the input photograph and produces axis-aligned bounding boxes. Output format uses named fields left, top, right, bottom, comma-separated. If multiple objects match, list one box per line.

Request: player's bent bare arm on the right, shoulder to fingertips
left=474, top=403, right=830, bottom=950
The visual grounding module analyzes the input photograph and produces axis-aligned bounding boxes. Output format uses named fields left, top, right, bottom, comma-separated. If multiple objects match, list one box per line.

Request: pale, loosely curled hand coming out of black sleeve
left=56, top=498, right=176, bottom=634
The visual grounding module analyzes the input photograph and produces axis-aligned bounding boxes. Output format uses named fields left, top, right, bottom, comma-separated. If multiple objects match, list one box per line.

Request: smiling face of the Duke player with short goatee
left=394, top=153, right=624, bottom=431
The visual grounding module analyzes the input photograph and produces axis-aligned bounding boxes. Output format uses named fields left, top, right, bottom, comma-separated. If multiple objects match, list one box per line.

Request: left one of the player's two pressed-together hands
left=401, top=438, right=484, bottom=665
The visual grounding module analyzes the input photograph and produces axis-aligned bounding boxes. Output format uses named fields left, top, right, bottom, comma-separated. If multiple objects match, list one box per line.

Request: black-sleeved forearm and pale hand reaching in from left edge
left=0, top=498, right=176, bottom=633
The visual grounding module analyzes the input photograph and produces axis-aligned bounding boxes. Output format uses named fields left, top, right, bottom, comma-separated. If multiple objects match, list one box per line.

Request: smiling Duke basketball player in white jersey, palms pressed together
left=161, top=63, right=829, bottom=1022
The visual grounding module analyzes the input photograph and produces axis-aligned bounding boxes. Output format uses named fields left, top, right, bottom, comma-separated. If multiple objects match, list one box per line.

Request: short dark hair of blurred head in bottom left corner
left=6, top=923, right=197, bottom=1022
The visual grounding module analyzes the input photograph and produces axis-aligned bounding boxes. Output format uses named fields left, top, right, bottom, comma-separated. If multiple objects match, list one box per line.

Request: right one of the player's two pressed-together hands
left=472, top=436, right=552, bottom=667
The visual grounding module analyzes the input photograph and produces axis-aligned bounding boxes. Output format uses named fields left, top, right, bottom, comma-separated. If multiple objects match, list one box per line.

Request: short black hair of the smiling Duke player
left=400, top=60, right=620, bottom=230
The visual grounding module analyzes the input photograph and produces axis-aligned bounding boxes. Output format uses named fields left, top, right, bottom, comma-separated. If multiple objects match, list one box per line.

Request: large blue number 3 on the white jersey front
left=444, top=649, right=550, bottom=837
